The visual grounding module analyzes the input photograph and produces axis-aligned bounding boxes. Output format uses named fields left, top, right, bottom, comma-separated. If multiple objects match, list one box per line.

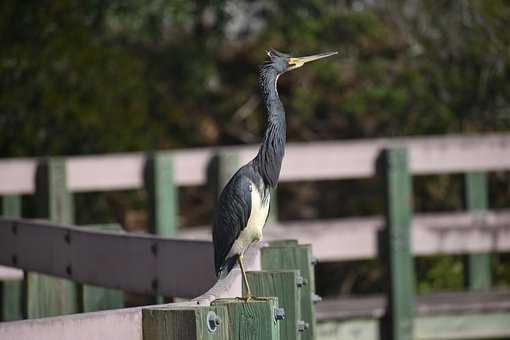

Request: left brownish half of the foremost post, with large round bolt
left=142, top=304, right=230, bottom=340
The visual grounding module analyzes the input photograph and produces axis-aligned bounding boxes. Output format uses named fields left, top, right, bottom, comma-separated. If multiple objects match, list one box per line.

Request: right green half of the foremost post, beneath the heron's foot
left=213, top=298, right=280, bottom=340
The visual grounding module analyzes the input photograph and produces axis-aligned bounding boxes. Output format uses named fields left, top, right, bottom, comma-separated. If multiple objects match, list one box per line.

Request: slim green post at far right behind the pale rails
left=464, top=172, right=491, bottom=290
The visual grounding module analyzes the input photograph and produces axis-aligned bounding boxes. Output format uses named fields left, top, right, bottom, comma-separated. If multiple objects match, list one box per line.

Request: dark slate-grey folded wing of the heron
left=213, top=172, right=252, bottom=273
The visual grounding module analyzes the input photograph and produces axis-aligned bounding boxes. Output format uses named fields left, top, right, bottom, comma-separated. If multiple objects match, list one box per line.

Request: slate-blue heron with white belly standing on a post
left=213, top=49, right=337, bottom=300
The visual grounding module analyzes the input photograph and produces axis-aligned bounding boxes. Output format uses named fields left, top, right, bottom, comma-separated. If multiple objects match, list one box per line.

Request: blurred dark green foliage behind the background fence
left=0, top=0, right=510, bottom=292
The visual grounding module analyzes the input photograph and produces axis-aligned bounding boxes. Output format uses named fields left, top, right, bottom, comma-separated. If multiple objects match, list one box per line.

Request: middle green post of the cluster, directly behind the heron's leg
left=247, top=270, right=302, bottom=340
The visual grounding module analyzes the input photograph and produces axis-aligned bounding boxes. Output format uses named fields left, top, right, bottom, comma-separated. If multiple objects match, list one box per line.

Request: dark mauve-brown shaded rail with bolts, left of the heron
left=0, top=218, right=216, bottom=298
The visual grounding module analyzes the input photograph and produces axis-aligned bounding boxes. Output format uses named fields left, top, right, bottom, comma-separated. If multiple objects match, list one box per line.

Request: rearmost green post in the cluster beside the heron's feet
left=261, top=240, right=316, bottom=340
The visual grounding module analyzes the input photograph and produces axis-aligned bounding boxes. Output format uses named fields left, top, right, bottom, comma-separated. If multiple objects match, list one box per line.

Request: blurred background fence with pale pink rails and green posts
left=0, top=135, right=510, bottom=339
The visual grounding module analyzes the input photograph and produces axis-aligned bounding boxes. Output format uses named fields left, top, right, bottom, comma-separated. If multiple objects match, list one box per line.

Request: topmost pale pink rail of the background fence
left=0, top=134, right=510, bottom=195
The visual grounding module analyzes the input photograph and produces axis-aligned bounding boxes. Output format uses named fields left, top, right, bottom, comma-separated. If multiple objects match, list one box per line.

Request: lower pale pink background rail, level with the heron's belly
left=178, top=210, right=510, bottom=261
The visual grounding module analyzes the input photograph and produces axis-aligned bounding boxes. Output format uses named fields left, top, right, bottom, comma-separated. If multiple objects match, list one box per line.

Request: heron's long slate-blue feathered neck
left=254, top=66, right=286, bottom=187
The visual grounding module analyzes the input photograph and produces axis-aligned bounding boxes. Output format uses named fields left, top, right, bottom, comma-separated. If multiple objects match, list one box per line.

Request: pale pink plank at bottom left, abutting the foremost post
left=0, top=308, right=143, bottom=340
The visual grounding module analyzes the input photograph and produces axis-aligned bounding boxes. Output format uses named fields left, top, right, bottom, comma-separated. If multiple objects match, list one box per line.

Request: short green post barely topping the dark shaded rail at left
left=81, top=224, right=124, bottom=313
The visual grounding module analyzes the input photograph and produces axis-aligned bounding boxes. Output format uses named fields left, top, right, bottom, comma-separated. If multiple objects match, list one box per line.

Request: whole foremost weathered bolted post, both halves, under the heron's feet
left=142, top=298, right=280, bottom=340
